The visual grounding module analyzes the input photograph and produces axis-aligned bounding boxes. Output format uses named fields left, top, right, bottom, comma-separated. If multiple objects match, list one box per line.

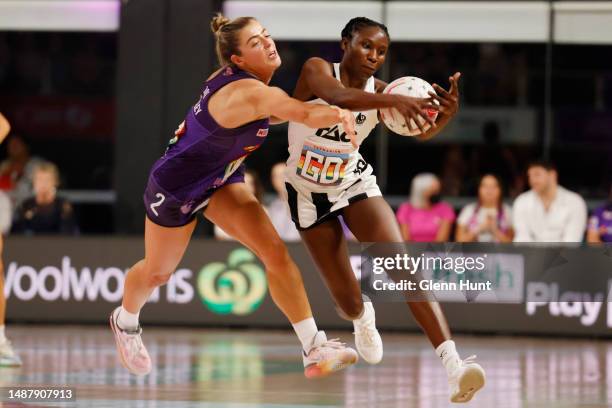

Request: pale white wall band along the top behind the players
left=0, top=0, right=612, bottom=44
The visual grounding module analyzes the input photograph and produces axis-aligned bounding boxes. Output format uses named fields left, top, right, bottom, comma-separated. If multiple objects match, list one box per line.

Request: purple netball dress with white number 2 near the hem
left=144, top=66, right=269, bottom=227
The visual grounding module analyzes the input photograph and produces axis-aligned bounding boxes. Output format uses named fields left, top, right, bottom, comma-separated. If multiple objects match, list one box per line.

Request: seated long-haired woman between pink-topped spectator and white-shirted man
left=456, top=174, right=513, bottom=242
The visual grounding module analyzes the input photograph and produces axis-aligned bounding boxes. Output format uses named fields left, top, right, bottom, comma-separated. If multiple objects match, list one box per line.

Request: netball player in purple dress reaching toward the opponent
left=110, top=15, right=357, bottom=377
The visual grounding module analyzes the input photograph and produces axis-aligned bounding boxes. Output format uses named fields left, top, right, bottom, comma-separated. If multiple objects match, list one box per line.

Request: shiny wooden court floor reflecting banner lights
left=0, top=326, right=612, bottom=408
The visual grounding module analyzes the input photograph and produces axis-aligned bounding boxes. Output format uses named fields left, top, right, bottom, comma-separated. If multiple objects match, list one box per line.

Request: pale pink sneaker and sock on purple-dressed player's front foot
left=302, top=331, right=359, bottom=378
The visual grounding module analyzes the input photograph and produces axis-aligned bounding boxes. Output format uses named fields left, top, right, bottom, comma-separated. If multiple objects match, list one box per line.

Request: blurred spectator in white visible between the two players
left=268, top=162, right=300, bottom=241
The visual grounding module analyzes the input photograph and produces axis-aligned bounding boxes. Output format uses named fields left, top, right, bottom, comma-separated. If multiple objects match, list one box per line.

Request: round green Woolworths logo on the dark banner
left=198, top=248, right=267, bottom=315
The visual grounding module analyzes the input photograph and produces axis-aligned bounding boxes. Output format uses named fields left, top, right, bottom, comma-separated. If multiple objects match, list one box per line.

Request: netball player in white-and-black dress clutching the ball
left=286, top=17, right=484, bottom=402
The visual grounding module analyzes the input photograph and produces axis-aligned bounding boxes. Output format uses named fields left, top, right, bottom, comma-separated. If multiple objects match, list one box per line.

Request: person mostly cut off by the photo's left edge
left=0, top=113, right=21, bottom=367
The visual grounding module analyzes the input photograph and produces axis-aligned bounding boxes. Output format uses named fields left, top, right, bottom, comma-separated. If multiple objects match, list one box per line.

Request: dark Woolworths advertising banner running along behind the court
left=4, top=237, right=612, bottom=336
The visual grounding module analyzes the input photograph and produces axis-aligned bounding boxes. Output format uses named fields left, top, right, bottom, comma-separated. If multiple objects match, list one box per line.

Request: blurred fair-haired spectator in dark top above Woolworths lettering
left=13, top=163, right=78, bottom=235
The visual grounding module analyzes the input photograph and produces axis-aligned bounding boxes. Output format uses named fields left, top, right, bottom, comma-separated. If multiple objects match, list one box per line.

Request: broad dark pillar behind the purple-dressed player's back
left=114, top=0, right=221, bottom=233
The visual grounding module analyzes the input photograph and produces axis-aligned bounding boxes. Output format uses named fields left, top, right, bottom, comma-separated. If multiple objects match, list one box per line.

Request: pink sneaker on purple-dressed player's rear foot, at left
left=110, top=307, right=151, bottom=375
